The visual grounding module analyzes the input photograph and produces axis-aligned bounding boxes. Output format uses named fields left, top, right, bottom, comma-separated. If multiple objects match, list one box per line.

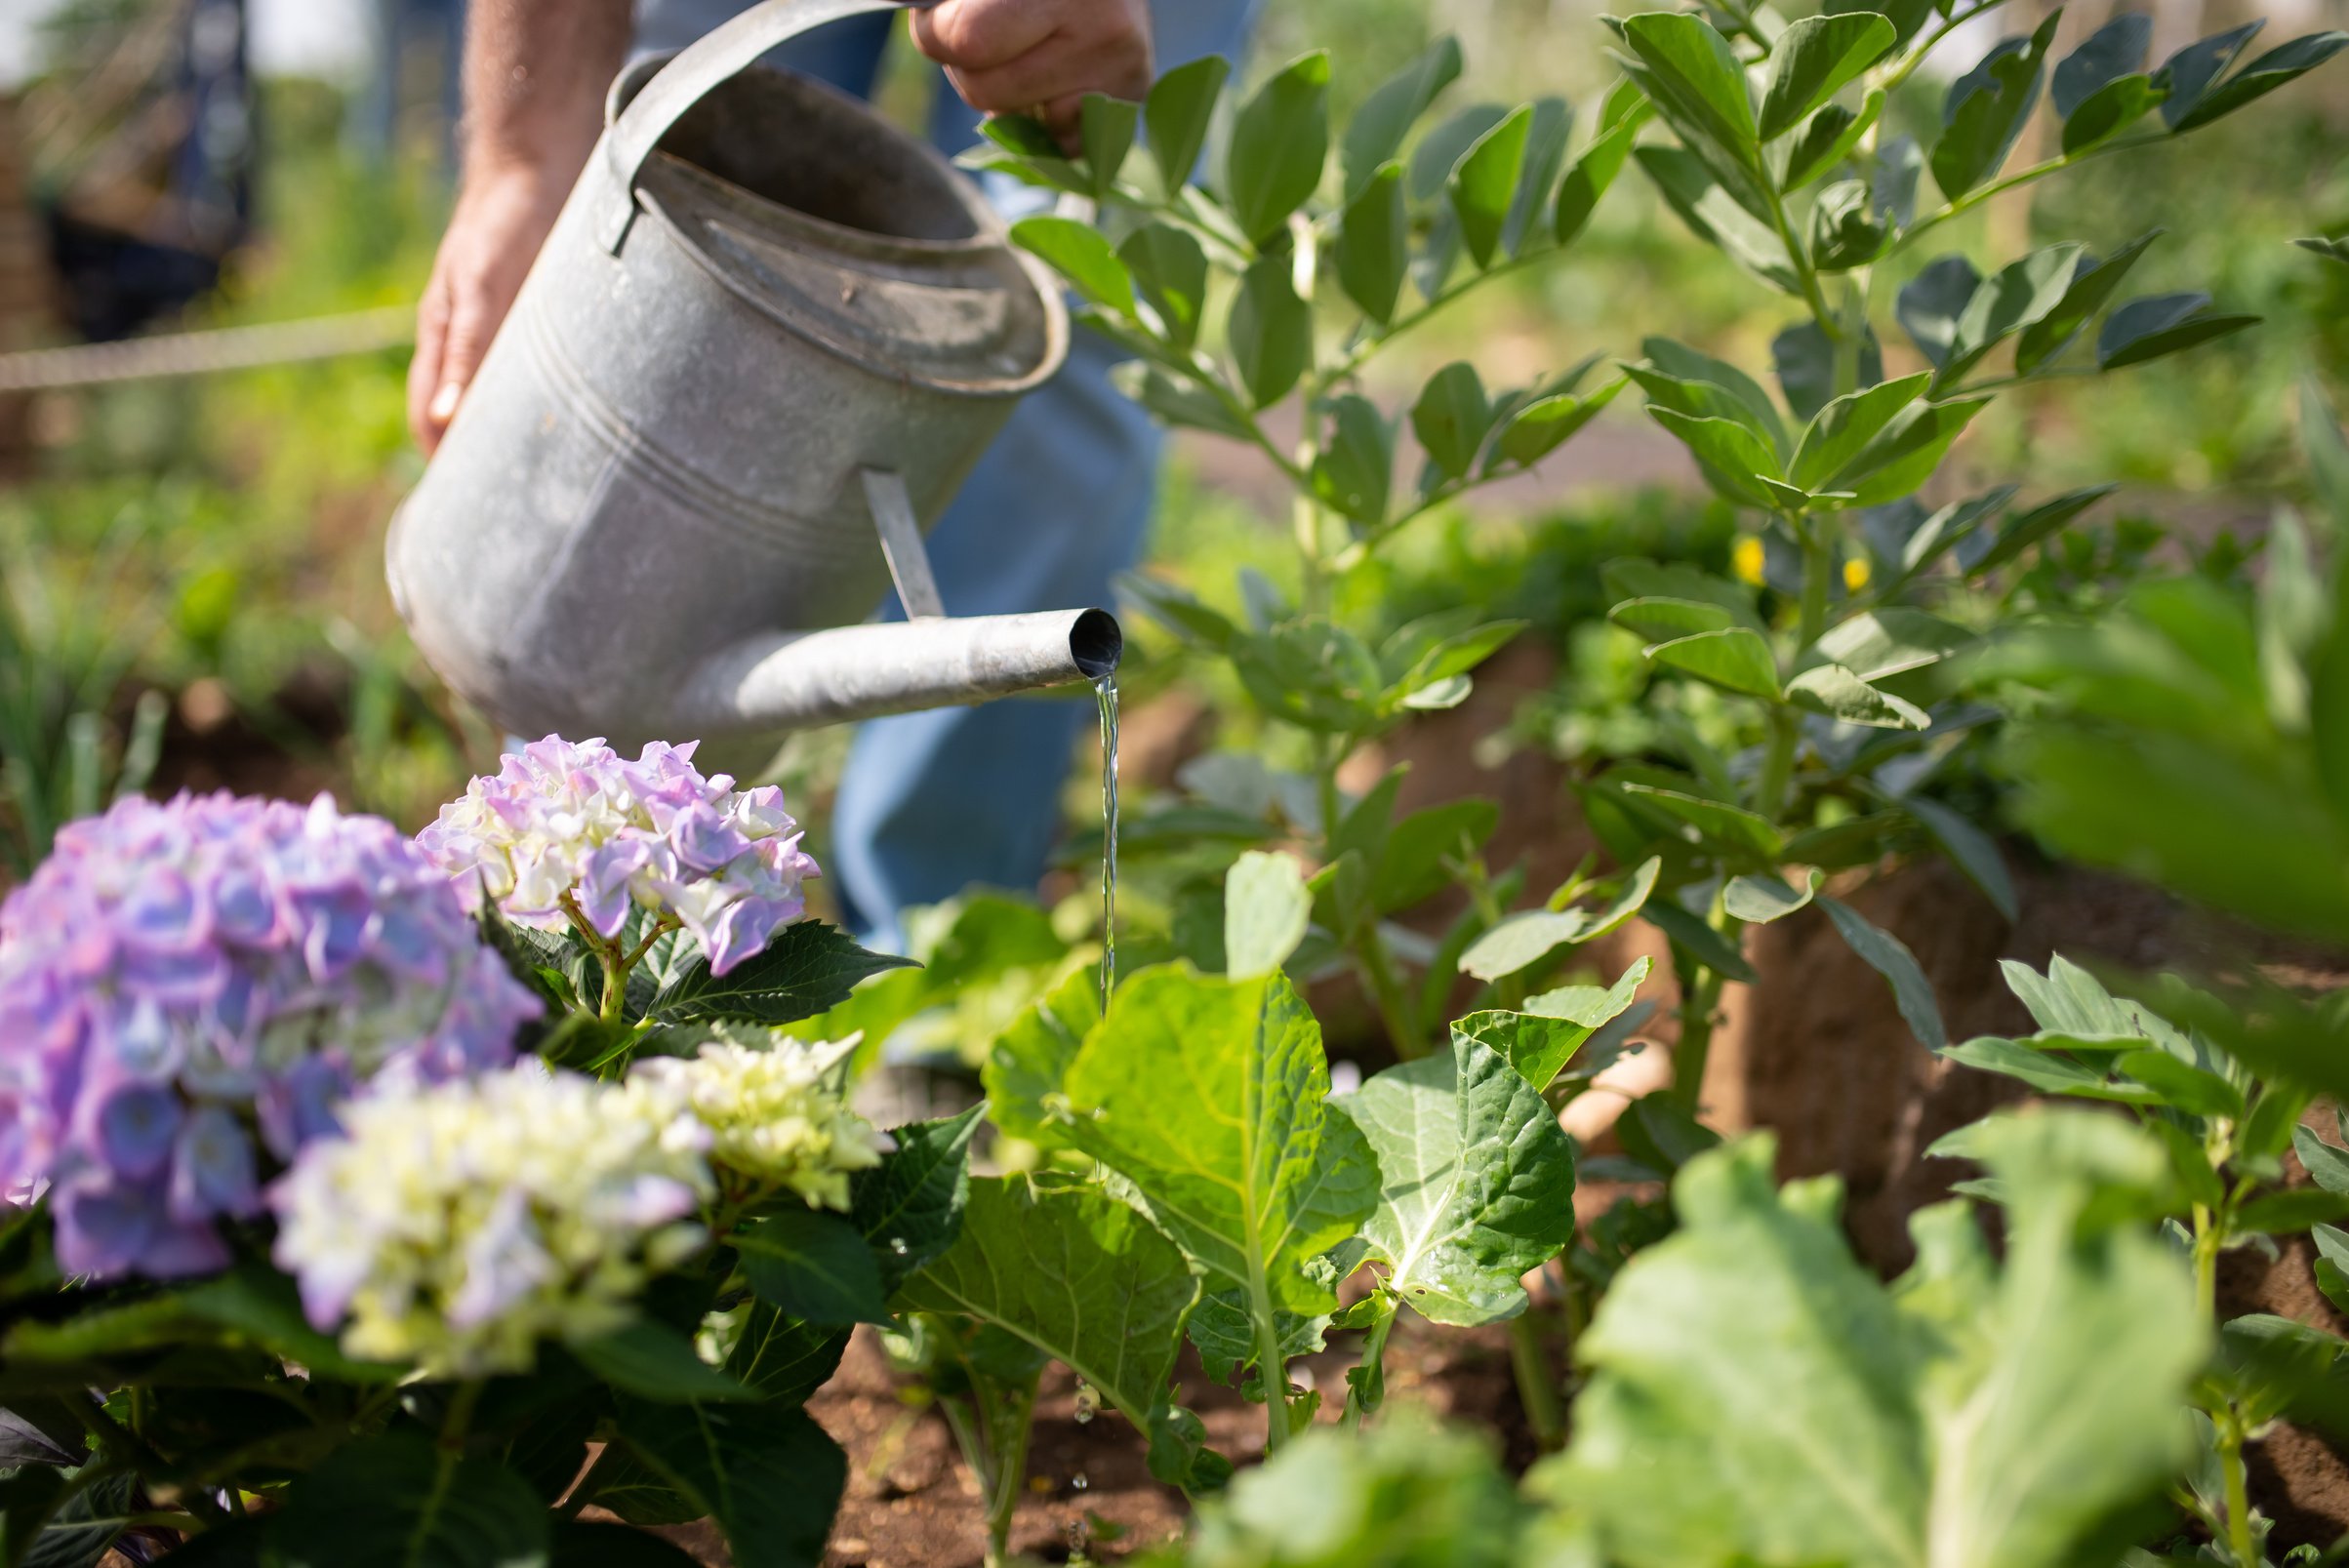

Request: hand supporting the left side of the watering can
left=409, top=164, right=571, bottom=453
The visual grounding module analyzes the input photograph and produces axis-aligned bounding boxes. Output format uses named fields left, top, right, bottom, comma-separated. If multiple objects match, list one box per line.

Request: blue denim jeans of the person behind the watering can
left=636, top=0, right=1254, bottom=948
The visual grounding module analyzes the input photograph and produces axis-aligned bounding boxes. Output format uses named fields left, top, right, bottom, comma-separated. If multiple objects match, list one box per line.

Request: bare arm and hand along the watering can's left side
left=409, top=0, right=629, bottom=451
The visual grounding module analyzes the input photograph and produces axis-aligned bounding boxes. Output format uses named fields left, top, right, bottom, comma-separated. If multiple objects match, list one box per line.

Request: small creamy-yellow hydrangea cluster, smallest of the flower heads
left=629, top=1037, right=890, bottom=1209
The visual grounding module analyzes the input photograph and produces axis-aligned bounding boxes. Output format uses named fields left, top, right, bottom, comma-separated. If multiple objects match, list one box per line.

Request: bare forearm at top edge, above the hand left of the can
left=451, top=0, right=629, bottom=187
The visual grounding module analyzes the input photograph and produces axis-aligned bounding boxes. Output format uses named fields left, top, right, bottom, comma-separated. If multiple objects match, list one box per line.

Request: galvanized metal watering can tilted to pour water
left=387, top=0, right=1120, bottom=744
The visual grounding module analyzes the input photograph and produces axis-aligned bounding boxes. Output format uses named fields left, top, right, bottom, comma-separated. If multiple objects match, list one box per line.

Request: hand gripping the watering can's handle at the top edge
left=913, top=0, right=1151, bottom=150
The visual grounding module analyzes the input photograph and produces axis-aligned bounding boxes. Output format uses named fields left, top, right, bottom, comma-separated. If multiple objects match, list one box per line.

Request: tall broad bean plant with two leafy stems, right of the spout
left=975, top=0, right=2349, bottom=1089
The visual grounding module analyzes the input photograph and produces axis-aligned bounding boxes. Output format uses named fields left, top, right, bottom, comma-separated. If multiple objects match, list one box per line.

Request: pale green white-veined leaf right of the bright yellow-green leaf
left=1341, top=1030, right=1574, bottom=1326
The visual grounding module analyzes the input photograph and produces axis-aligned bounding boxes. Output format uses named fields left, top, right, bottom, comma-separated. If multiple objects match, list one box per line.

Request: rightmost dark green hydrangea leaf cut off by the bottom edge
left=615, top=1399, right=848, bottom=1568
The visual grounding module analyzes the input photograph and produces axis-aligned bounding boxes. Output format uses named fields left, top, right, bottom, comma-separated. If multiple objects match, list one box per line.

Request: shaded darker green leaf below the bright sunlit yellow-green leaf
left=897, top=1176, right=1198, bottom=1481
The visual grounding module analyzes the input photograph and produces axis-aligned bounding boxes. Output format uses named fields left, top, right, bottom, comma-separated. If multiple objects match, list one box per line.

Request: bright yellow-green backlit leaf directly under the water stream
left=1069, top=965, right=1377, bottom=1314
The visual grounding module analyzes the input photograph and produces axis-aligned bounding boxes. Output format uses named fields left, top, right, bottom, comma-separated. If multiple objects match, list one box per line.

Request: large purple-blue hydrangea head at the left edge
left=0, top=793, right=541, bottom=1277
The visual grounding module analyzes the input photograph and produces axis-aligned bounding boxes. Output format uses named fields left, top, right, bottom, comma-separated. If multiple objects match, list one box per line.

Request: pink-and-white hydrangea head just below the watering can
left=418, top=735, right=818, bottom=974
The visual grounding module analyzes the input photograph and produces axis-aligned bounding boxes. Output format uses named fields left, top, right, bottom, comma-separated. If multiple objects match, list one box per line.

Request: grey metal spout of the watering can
left=679, top=610, right=1125, bottom=735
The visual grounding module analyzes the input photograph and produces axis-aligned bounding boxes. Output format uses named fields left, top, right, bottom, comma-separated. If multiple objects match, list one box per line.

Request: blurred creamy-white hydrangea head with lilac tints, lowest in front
left=270, top=1061, right=711, bottom=1378
